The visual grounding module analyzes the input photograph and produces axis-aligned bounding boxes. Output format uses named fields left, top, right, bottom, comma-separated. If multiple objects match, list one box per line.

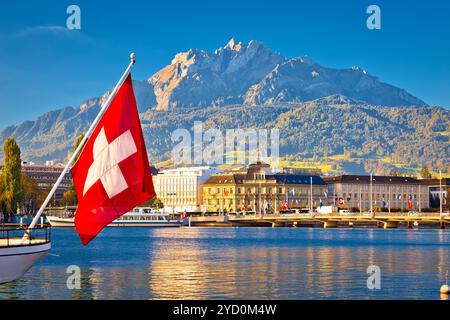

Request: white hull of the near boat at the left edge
left=0, top=242, right=51, bottom=283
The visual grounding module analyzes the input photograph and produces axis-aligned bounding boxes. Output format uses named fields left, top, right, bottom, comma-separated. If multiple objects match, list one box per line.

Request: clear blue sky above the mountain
left=0, top=0, right=450, bottom=129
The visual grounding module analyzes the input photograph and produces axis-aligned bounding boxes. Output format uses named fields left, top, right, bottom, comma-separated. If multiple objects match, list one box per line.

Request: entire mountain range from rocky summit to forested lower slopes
left=0, top=39, right=450, bottom=175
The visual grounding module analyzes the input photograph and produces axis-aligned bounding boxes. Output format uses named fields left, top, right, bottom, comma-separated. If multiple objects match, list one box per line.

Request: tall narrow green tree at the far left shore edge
left=2, top=137, right=24, bottom=214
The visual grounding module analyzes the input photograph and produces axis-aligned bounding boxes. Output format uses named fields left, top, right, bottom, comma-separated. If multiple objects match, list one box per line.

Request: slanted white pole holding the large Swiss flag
left=23, top=53, right=136, bottom=239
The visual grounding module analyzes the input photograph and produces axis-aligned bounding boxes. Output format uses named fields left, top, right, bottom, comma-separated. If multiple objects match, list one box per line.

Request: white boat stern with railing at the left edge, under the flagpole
left=0, top=224, right=51, bottom=283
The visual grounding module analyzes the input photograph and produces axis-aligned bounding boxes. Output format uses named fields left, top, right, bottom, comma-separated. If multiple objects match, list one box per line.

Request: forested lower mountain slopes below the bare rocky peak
left=0, top=96, right=450, bottom=173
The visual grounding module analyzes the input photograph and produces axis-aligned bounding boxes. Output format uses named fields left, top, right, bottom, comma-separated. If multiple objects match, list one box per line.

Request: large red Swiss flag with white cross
left=71, top=75, right=155, bottom=245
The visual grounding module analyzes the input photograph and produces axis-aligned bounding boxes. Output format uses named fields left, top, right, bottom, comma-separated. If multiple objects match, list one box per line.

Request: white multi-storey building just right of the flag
left=153, top=167, right=222, bottom=212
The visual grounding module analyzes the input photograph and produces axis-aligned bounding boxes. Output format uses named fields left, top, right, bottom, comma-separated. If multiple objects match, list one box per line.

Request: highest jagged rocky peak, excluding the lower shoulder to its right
left=148, top=38, right=284, bottom=110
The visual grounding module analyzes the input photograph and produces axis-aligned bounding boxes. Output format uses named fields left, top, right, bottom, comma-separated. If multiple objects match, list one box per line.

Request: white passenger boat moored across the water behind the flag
left=46, top=208, right=187, bottom=227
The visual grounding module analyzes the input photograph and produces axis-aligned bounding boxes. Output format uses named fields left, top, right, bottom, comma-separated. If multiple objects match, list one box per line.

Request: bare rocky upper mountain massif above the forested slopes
left=147, top=39, right=427, bottom=110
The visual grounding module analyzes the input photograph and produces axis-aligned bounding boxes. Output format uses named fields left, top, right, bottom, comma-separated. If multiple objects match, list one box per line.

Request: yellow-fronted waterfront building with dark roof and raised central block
left=203, top=163, right=327, bottom=213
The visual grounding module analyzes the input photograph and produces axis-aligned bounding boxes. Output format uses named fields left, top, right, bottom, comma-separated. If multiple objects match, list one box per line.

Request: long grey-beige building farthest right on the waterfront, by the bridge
left=325, top=175, right=430, bottom=211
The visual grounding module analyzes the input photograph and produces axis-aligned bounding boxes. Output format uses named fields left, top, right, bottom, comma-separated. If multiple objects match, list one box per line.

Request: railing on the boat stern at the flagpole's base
left=0, top=223, right=51, bottom=247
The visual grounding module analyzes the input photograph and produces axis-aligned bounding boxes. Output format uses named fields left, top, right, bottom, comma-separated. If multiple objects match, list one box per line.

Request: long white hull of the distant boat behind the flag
left=47, top=216, right=186, bottom=228
